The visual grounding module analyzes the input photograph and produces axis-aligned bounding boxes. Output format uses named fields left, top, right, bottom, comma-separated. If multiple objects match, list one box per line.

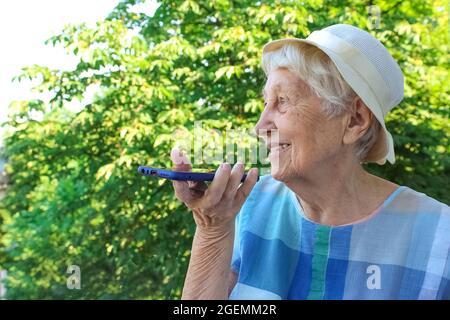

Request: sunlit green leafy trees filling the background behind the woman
left=0, top=0, right=450, bottom=299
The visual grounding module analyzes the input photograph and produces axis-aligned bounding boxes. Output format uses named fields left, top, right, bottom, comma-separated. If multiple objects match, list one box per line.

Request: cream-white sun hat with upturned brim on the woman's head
left=263, top=24, right=404, bottom=164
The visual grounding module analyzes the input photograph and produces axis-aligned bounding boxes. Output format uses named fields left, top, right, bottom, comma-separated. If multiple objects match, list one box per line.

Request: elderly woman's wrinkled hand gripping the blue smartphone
left=171, top=149, right=258, bottom=231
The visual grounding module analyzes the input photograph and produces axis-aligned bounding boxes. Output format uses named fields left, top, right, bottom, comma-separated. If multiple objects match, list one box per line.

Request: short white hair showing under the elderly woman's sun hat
left=262, top=43, right=381, bottom=161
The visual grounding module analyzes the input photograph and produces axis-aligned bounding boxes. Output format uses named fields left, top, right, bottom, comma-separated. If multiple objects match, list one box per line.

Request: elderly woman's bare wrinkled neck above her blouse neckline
left=286, top=164, right=398, bottom=226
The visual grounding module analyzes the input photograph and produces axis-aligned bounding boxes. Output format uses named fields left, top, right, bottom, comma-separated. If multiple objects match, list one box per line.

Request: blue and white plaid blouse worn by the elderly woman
left=230, top=176, right=450, bottom=300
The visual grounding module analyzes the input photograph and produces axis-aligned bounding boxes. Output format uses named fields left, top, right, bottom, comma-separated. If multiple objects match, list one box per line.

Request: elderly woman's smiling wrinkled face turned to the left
left=255, top=68, right=345, bottom=182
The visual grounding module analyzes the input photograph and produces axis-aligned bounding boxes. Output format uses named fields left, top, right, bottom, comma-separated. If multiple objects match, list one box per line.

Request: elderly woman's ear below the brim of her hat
left=343, top=96, right=373, bottom=144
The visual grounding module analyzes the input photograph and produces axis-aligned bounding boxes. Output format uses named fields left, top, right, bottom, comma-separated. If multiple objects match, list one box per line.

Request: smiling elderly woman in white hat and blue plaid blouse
left=172, top=25, right=450, bottom=299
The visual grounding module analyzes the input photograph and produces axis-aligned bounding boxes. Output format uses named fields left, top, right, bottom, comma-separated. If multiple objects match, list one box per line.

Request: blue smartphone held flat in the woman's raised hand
left=138, top=166, right=259, bottom=182
